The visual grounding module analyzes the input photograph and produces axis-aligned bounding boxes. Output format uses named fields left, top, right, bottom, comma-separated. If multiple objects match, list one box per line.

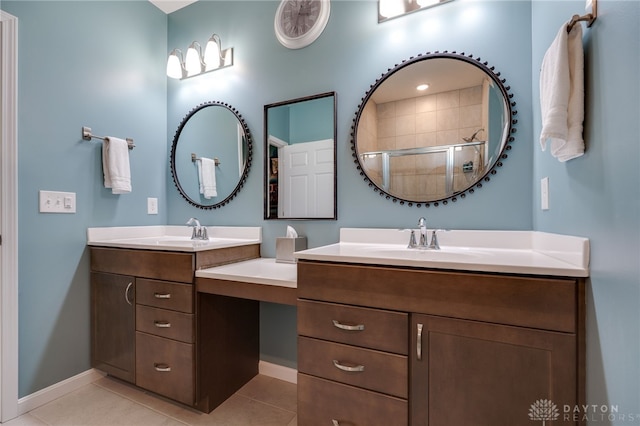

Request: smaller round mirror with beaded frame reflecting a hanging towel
left=171, top=101, right=252, bottom=209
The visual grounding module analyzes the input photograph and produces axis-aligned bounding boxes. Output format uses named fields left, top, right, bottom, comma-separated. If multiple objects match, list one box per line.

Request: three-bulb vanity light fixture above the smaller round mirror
left=167, top=34, right=233, bottom=80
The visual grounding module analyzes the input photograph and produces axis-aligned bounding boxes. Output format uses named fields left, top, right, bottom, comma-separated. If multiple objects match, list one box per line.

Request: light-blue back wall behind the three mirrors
left=167, top=0, right=533, bottom=367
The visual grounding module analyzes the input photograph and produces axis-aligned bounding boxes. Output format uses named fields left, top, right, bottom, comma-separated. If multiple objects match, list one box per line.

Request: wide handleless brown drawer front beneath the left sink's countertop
left=90, top=247, right=195, bottom=283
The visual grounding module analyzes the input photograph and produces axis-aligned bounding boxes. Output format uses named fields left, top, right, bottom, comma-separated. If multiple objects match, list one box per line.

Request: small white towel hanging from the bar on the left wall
left=102, top=136, right=131, bottom=194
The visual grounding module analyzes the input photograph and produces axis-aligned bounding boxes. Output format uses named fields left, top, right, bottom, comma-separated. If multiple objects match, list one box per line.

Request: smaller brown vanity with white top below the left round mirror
left=88, top=227, right=261, bottom=412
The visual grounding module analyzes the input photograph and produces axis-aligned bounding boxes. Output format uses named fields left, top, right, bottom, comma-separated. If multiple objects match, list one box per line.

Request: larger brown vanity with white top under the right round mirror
left=297, top=229, right=588, bottom=426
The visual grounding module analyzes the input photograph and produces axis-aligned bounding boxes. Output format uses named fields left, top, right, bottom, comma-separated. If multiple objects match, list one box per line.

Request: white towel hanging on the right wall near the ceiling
left=540, top=23, right=584, bottom=162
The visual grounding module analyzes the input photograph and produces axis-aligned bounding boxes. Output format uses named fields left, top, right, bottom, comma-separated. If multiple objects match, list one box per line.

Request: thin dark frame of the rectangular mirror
left=263, top=92, right=338, bottom=220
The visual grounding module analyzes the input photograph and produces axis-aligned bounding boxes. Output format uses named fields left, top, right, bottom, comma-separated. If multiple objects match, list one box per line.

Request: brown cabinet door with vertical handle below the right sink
left=410, top=314, right=577, bottom=426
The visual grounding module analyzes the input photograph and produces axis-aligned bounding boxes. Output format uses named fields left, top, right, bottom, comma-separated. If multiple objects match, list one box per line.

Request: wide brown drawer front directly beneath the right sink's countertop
left=298, top=261, right=584, bottom=333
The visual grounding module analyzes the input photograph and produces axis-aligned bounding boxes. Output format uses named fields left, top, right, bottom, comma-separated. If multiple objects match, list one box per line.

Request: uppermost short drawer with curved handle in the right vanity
left=298, top=300, right=409, bottom=355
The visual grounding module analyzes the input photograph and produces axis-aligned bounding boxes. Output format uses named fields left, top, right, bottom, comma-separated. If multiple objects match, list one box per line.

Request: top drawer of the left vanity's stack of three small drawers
left=136, top=278, right=193, bottom=314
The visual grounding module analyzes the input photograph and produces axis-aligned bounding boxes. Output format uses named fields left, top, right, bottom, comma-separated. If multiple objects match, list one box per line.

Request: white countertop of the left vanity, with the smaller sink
left=87, top=226, right=262, bottom=252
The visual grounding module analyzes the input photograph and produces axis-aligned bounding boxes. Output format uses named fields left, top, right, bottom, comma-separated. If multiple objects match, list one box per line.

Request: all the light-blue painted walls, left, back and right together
left=2, top=0, right=640, bottom=424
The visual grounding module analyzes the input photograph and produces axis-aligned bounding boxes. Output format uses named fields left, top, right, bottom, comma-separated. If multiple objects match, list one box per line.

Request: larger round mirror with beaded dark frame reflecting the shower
left=352, top=52, right=517, bottom=207
